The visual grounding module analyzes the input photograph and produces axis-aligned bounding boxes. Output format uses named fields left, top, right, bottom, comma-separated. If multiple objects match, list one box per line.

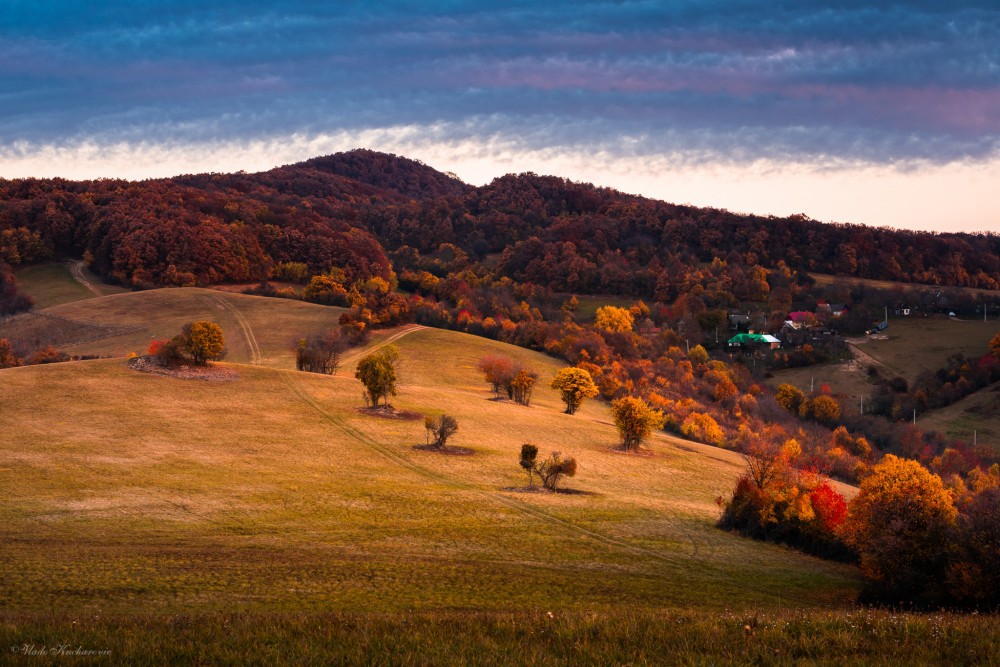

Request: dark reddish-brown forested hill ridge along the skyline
left=0, top=150, right=1000, bottom=294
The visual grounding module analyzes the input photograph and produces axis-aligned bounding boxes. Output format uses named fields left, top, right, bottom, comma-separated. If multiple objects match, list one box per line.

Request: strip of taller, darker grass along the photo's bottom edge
left=0, top=609, right=1000, bottom=665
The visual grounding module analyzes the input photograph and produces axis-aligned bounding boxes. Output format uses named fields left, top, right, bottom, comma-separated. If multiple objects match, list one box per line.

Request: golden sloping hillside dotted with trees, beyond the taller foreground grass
left=0, top=298, right=857, bottom=613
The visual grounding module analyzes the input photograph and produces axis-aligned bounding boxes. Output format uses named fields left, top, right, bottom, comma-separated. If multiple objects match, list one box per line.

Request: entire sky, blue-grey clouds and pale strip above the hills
left=0, top=0, right=1000, bottom=232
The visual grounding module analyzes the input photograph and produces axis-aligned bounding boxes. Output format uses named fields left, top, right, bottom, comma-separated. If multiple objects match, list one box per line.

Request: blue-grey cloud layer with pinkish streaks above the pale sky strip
left=0, top=0, right=1000, bottom=163
